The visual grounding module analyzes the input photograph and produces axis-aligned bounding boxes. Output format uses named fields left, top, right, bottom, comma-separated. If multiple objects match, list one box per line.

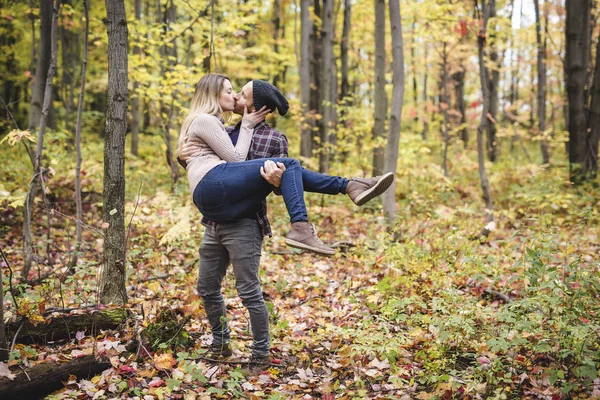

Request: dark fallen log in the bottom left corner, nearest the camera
left=0, top=355, right=110, bottom=399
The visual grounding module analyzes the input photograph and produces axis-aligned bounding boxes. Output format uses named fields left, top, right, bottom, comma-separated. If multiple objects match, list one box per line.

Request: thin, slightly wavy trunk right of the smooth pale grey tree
left=477, top=0, right=494, bottom=236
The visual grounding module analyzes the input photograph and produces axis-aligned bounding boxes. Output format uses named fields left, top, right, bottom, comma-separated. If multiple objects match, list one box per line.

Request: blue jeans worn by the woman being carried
left=194, top=158, right=348, bottom=223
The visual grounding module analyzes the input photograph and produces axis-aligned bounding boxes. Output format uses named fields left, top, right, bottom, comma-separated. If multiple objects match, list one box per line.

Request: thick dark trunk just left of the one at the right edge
left=565, top=0, right=600, bottom=183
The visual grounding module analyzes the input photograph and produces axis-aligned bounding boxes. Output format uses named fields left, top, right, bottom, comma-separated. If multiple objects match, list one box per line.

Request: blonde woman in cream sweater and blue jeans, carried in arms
left=178, top=74, right=393, bottom=255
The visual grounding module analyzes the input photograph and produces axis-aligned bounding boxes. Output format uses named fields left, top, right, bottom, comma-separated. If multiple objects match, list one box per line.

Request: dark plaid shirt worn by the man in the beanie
left=201, top=121, right=288, bottom=236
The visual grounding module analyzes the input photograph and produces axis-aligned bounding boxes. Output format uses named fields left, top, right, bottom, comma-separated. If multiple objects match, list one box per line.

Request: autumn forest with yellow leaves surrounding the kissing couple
left=0, top=0, right=600, bottom=400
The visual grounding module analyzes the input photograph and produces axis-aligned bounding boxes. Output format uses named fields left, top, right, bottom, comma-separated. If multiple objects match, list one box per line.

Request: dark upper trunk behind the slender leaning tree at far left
left=29, top=0, right=53, bottom=131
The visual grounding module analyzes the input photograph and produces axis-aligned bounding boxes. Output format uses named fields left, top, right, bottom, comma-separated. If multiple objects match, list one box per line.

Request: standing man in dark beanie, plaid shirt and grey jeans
left=191, top=80, right=289, bottom=364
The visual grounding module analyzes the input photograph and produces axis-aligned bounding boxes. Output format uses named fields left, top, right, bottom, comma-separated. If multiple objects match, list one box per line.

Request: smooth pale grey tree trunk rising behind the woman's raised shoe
left=383, top=0, right=404, bottom=227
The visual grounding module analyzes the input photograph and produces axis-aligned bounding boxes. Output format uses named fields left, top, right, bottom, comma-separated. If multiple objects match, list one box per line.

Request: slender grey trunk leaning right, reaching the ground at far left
left=22, top=0, right=60, bottom=279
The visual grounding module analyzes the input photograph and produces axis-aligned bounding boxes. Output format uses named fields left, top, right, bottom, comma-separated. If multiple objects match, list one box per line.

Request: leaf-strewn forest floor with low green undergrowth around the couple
left=0, top=133, right=600, bottom=400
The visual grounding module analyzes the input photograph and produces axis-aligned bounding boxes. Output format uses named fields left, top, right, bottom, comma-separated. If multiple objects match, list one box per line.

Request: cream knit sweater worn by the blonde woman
left=179, top=114, right=253, bottom=195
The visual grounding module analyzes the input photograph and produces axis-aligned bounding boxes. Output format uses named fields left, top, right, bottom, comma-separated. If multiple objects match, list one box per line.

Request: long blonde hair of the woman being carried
left=177, top=74, right=230, bottom=153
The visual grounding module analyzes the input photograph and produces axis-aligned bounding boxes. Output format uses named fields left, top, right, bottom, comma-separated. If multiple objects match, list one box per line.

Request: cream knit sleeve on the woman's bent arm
left=189, top=115, right=252, bottom=162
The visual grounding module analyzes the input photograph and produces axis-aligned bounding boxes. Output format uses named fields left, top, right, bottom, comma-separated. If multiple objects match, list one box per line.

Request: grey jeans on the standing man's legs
left=198, top=218, right=270, bottom=357
